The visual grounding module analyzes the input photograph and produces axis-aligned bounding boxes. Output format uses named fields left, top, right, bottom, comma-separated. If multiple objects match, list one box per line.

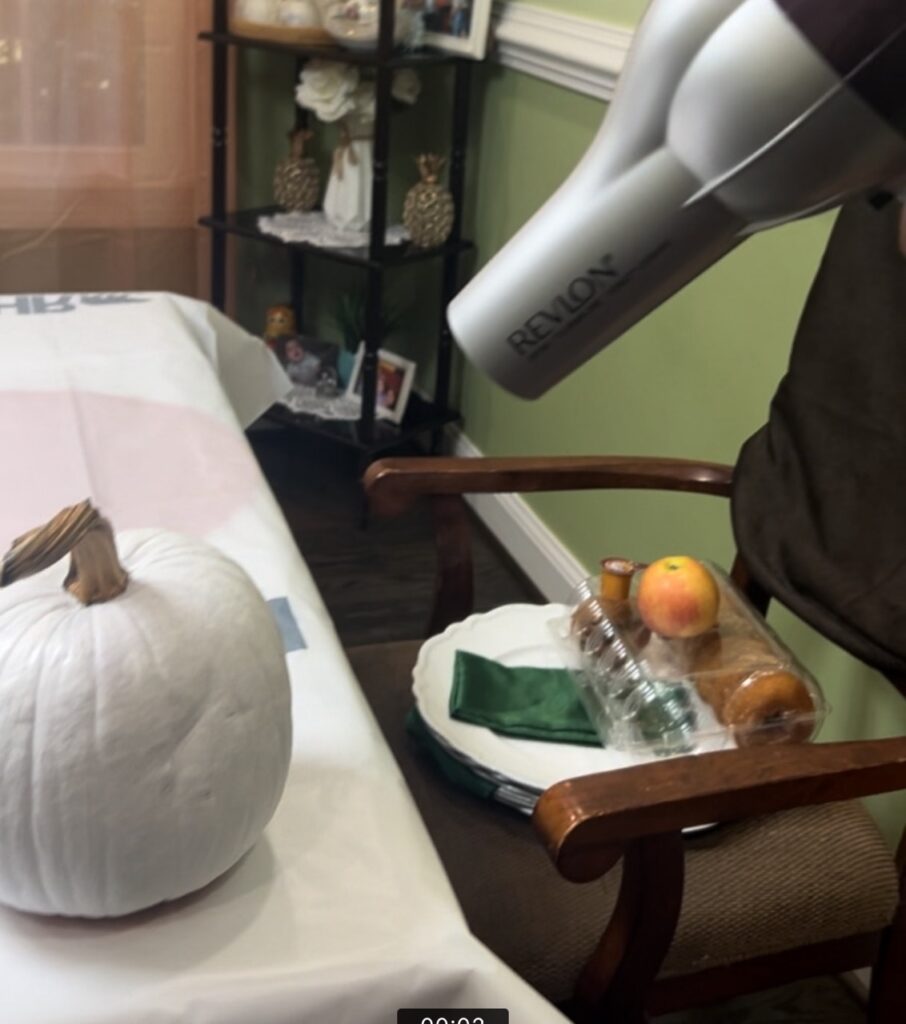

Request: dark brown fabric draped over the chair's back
left=732, top=202, right=906, bottom=674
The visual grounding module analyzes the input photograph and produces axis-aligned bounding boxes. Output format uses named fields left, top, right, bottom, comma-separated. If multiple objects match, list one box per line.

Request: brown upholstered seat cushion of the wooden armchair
left=348, top=642, right=898, bottom=1002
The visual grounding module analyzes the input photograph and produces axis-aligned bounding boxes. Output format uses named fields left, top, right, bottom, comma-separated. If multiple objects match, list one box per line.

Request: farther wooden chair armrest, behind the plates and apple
left=363, top=456, right=733, bottom=516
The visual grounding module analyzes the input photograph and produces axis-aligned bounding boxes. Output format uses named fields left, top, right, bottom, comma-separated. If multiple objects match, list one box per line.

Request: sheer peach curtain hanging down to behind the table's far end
left=0, top=0, right=211, bottom=296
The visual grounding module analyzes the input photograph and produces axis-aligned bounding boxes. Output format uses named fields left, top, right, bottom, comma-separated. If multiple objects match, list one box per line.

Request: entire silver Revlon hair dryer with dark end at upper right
left=447, top=0, right=906, bottom=398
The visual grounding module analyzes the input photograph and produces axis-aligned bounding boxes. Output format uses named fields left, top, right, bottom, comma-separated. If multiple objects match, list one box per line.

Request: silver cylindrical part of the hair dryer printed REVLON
left=447, top=150, right=744, bottom=398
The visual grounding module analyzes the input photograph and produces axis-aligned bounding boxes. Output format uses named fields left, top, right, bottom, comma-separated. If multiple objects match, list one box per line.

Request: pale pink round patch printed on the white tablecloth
left=0, top=391, right=261, bottom=553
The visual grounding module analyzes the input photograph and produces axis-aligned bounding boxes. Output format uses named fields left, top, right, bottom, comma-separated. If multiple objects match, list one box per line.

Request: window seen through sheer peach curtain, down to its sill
left=0, top=0, right=209, bottom=230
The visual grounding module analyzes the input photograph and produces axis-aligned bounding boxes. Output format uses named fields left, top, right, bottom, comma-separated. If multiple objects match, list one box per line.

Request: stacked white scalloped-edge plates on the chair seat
left=413, top=604, right=638, bottom=814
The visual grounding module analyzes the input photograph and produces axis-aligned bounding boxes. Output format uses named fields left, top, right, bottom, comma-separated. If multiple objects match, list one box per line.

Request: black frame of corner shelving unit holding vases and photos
left=199, top=0, right=473, bottom=461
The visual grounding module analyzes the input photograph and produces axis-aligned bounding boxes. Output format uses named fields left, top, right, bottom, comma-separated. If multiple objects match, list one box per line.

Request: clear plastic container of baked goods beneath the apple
left=563, top=559, right=827, bottom=758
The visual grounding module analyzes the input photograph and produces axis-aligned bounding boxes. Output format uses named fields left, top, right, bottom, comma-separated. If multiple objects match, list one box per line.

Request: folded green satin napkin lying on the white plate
left=449, top=650, right=601, bottom=746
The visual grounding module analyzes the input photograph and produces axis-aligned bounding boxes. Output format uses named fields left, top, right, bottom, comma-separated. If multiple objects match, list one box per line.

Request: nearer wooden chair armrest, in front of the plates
left=532, top=736, right=906, bottom=882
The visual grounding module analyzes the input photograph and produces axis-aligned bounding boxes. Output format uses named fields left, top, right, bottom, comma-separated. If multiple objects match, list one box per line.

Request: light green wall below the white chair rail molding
left=461, top=59, right=906, bottom=842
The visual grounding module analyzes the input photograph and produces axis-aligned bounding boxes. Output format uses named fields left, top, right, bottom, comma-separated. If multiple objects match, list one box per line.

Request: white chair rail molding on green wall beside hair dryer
left=492, top=0, right=634, bottom=100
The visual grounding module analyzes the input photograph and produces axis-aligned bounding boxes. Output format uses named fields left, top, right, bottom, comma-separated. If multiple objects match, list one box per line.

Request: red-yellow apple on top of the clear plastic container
left=636, top=555, right=721, bottom=638
